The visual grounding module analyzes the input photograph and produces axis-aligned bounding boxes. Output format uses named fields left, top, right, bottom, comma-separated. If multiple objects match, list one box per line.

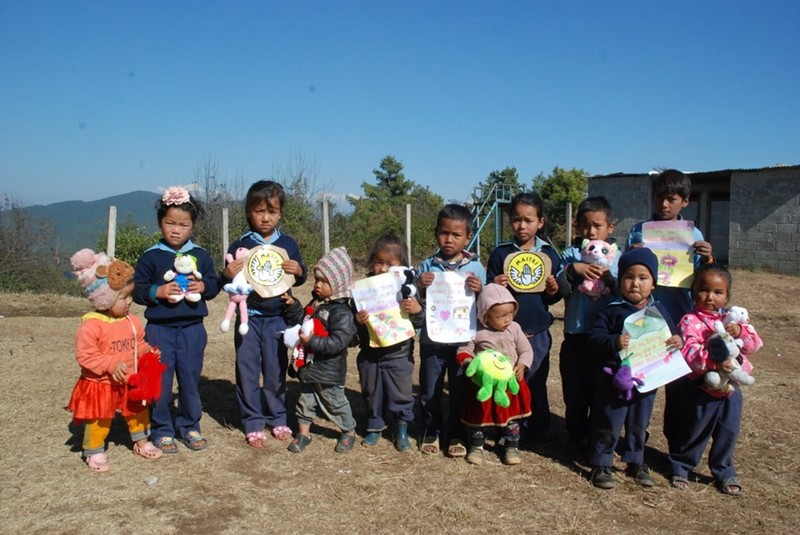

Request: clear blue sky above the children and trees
left=0, top=0, right=800, bottom=205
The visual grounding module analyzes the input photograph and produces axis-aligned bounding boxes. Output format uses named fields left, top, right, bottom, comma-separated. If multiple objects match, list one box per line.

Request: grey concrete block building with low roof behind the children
left=589, top=165, right=800, bottom=274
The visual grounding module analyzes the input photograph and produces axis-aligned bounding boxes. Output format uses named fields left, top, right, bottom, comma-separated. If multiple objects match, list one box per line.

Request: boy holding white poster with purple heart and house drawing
left=417, top=204, right=486, bottom=457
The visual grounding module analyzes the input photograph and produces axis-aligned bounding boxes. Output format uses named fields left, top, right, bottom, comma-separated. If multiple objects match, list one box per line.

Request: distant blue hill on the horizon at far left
left=25, top=191, right=161, bottom=256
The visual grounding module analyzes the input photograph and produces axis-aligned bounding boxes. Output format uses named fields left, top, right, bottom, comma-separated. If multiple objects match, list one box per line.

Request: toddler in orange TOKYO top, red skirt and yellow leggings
left=67, top=249, right=162, bottom=472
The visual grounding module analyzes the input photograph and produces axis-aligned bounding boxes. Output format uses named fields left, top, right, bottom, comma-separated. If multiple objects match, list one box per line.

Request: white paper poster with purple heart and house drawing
left=425, top=271, right=478, bottom=344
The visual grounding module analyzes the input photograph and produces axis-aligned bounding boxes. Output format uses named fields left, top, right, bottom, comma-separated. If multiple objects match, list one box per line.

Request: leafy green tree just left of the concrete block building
left=533, top=166, right=589, bottom=247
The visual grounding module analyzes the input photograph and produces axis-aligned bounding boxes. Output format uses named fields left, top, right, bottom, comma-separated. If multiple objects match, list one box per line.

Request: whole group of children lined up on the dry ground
left=69, top=170, right=761, bottom=495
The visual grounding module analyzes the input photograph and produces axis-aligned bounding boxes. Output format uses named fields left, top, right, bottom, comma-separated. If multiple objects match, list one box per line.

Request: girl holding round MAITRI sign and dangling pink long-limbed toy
left=222, top=180, right=308, bottom=448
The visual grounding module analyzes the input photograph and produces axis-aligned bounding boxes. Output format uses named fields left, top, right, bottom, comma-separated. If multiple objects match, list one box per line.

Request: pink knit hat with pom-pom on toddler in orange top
left=70, top=249, right=133, bottom=310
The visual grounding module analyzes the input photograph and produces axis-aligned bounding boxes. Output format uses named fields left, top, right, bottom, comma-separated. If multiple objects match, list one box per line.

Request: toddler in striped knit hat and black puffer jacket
left=284, top=247, right=356, bottom=453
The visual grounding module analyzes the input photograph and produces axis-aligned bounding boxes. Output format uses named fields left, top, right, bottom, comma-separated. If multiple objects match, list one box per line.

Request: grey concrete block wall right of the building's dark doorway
left=729, top=168, right=800, bottom=274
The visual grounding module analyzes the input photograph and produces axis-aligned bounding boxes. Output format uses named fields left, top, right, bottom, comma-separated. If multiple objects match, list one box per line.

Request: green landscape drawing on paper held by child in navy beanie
left=619, top=307, right=691, bottom=392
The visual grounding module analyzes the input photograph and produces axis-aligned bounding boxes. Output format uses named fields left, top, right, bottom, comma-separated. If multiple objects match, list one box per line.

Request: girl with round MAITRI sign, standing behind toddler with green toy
left=486, top=192, right=561, bottom=444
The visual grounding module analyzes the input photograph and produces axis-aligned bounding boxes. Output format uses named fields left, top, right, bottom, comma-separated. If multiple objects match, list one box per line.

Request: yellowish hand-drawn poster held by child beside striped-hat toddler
left=353, top=273, right=416, bottom=347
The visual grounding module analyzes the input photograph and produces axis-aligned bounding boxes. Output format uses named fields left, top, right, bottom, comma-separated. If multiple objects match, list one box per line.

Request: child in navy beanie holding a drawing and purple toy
left=589, top=247, right=683, bottom=489
